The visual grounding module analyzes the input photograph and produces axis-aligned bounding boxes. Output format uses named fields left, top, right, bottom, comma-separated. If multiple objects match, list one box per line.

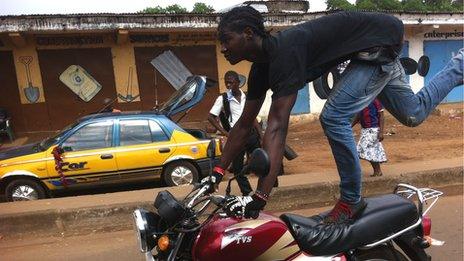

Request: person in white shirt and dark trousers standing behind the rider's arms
left=208, top=71, right=261, bottom=196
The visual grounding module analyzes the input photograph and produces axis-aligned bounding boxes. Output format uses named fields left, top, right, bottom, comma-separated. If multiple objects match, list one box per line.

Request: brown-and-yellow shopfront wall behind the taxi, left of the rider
left=0, top=30, right=218, bottom=132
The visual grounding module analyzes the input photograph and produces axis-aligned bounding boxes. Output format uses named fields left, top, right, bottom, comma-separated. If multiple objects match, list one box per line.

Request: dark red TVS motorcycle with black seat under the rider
left=133, top=142, right=443, bottom=261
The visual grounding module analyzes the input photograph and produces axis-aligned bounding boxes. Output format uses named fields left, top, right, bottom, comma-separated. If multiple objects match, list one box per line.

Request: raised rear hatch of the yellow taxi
left=158, top=75, right=216, bottom=117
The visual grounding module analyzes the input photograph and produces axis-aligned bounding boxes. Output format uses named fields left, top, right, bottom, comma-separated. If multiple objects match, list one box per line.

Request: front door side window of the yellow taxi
left=61, top=121, right=113, bottom=151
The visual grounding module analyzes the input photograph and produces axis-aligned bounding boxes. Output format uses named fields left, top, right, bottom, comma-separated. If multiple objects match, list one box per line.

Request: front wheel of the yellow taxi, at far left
left=5, top=179, right=47, bottom=201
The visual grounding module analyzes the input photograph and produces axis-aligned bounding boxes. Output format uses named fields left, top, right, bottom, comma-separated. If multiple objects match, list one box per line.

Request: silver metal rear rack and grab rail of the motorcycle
left=362, top=183, right=443, bottom=248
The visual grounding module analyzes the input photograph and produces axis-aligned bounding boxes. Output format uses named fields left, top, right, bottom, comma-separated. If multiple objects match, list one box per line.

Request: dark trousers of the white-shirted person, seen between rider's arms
left=232, top=130, right=260, bottom=196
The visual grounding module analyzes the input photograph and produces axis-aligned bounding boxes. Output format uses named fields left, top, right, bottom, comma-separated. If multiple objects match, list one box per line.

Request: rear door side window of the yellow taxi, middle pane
left=119, top=120, right=152, bottom=146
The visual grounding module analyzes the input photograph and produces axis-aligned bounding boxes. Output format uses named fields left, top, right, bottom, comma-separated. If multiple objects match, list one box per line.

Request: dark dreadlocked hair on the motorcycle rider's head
left=218, top=6, right=267, bottom=37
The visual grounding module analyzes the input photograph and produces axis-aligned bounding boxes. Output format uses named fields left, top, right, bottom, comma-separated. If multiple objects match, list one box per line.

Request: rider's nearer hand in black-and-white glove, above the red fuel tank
left=224, top=193, right=266, bottom=218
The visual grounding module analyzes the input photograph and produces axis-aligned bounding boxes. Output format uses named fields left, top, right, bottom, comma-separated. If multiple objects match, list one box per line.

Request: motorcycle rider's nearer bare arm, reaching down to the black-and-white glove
left=258, top=93, right=297, bottom=195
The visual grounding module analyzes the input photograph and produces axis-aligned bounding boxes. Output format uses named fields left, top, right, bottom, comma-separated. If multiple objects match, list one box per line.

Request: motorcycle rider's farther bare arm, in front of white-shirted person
left=219, top=97, right=264, bottom=169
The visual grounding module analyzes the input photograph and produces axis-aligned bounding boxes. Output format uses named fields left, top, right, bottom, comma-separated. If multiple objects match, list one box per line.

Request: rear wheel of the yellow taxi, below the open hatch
left=164, top=161, right=198, bottom=186
